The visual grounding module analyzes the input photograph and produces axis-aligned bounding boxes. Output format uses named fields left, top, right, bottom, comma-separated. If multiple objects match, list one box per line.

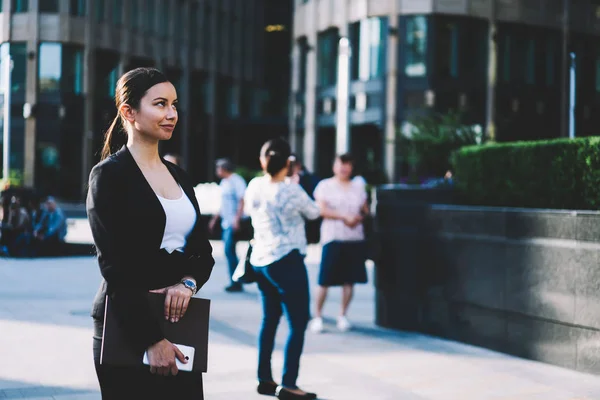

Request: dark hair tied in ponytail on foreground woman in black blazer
left=101, top=68, right=169, bottom=160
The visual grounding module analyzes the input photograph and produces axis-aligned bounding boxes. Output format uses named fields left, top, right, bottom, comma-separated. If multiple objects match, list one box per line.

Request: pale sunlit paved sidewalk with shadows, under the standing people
left=0, top=242, right=600, bottom=400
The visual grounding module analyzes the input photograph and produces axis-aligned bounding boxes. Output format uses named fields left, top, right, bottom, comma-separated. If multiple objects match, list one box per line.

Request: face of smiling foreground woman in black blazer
left=124, top=82, right=178, bottom=140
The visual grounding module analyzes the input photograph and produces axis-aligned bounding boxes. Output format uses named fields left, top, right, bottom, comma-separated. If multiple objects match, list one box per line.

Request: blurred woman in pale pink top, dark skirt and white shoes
left=310, top=154, right=369, bottom=333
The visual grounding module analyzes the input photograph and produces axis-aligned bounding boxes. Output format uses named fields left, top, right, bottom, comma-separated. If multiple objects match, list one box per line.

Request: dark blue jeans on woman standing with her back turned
left=254, top=250, right=310, bottom=389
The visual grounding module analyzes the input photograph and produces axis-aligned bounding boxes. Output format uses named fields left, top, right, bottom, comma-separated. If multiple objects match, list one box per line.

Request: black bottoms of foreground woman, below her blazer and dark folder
left=93, top=320, right=204, bottom=400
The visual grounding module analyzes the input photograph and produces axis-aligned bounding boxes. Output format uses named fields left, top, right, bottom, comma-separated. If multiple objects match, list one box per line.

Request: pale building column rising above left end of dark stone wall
left=383, top=8, right=400, bottom=182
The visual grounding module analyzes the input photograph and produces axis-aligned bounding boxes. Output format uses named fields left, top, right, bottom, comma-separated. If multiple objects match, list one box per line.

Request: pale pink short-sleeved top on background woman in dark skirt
left=315, top=178, right=367, bottom=244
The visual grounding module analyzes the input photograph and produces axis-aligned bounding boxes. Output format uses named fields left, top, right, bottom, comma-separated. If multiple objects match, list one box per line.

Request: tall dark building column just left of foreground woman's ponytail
left=81, top=0, right=96, bottom=199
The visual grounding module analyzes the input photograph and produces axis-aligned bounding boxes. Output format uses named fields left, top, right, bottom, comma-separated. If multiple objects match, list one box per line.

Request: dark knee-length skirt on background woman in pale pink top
left=319, top=241, right=367, bottom=286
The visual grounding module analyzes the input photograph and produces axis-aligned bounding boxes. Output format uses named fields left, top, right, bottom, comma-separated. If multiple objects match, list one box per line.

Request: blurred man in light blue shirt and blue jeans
left=209, top=158, right=246, bottom=292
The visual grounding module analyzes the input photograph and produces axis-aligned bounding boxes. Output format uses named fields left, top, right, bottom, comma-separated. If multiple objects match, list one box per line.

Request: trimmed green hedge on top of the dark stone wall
left=452, top=137, right=600, bottom=210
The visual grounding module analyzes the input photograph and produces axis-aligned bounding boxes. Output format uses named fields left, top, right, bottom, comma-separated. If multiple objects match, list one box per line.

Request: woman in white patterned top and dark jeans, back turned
left=244, top=139, right=319, bottom=400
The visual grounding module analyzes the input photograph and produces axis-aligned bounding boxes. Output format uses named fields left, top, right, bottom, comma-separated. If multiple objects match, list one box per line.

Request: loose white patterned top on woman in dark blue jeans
left=244, top=176, right=320, bottom=267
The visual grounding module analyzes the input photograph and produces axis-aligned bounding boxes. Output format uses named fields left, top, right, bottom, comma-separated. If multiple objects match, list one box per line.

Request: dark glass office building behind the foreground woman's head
left=0, top=0, right=292, bottom=200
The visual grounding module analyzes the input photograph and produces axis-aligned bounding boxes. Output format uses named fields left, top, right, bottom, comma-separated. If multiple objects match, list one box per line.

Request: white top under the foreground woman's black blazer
left=156, top=186, right=196, bottom=254
